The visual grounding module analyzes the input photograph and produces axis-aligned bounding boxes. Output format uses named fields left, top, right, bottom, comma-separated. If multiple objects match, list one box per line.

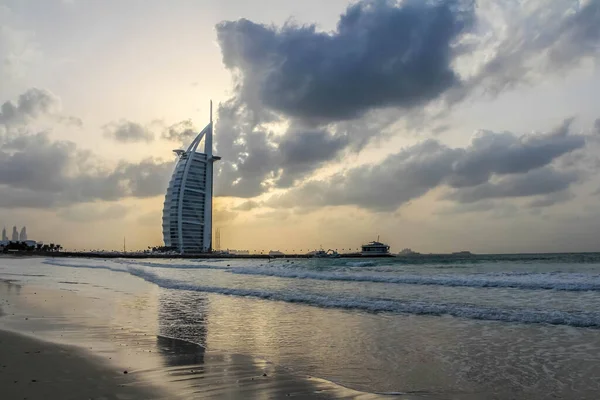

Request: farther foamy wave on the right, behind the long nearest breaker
left=229, top=267, right=600, bottom=291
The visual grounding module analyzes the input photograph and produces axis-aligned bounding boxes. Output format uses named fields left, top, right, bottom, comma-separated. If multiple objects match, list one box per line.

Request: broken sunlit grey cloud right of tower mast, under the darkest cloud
left=215, top=101, right=350, bottom=197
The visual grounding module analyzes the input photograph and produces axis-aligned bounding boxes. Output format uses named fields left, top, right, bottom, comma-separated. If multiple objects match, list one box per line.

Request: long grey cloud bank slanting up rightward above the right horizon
left=266, top=122, right=585, bottom=211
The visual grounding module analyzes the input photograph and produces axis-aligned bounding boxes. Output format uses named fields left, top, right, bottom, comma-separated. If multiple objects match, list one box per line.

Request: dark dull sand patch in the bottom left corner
left=0, top=331, right=165, bottom=400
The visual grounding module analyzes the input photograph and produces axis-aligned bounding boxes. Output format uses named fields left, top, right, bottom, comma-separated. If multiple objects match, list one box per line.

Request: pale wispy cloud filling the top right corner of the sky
left=451, top=0, right=600, bottom=101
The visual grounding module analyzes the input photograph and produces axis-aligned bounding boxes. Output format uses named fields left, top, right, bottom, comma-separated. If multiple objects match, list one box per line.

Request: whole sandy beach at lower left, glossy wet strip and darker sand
left=0, top=280, right=396, bottom=400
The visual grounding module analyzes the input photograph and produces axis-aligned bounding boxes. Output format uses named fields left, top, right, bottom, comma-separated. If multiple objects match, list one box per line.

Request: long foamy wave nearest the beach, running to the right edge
left=45, top=261, right=600, bottom=328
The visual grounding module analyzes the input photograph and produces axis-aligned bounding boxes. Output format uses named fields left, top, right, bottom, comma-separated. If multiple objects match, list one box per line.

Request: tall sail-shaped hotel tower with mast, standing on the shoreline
left=162, top=102, right=221, bottom=254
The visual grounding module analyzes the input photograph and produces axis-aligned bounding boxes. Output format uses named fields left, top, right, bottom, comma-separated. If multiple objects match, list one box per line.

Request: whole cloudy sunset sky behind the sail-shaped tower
left=0, top=0, right=600, bottom=253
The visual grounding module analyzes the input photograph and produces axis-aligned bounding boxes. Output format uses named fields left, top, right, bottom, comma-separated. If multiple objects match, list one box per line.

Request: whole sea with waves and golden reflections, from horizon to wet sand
left=0, top=253, right=600, bottom=399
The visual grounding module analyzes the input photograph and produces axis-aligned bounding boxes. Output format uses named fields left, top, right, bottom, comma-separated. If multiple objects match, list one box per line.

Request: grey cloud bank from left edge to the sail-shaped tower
left=0, top=133, right=173, bottom=208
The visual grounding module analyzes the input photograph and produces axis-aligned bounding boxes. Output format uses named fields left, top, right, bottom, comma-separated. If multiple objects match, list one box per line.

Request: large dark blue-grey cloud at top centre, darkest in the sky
left=217, top=0, right=474, bottom=120
